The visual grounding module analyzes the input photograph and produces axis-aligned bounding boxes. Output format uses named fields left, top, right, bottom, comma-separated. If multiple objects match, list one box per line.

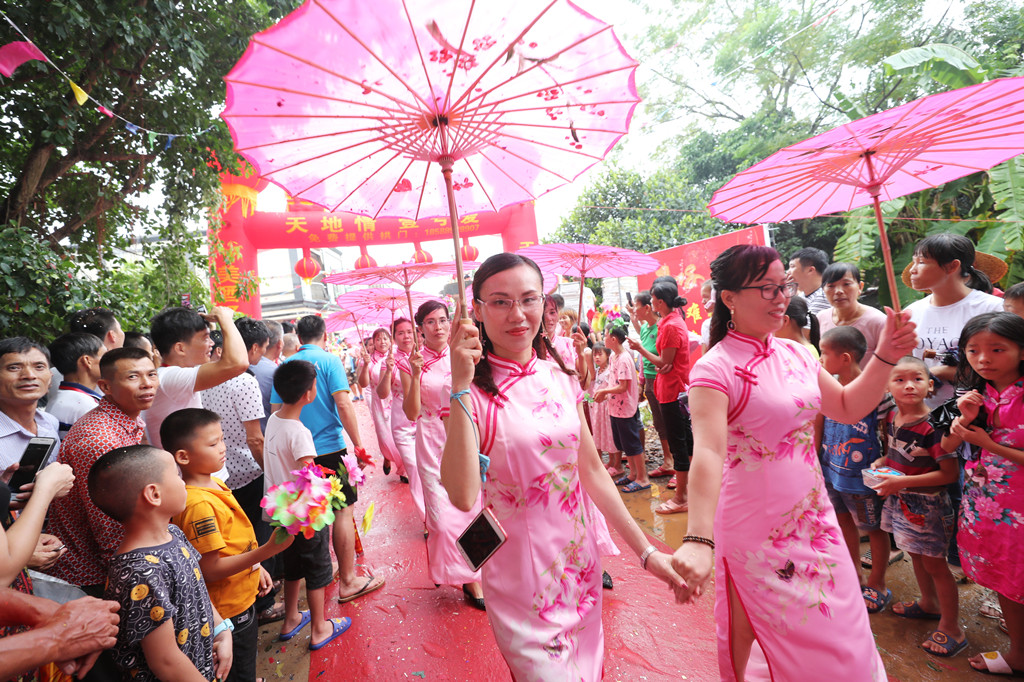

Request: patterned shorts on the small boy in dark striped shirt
left=882, top=491, right=956, bottom=559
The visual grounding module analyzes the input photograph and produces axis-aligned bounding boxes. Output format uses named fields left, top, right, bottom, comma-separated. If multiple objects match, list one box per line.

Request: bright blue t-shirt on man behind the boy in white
left=270, top=343, right=348, bottom=455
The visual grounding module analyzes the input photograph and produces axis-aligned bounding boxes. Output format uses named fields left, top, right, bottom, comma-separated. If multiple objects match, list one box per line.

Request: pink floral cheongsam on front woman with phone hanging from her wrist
left=453, top=355, right=604, bottom=682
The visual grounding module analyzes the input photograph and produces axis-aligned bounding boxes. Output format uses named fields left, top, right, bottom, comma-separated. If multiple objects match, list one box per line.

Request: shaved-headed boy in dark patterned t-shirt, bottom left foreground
left=89, top=445, right=231, bottom=682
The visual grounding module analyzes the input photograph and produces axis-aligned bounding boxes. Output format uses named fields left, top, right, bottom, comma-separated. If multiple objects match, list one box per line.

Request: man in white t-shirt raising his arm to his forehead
left=142, top=307, right=249, bottom=447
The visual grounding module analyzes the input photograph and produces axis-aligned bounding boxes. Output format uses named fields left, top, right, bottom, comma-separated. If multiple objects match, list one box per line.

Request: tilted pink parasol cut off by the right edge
left=708, top=77, right=1024, bottom=310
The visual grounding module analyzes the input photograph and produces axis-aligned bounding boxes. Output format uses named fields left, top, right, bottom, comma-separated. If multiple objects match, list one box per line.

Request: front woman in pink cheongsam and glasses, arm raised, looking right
left=673, top=246, right=916, bottom=681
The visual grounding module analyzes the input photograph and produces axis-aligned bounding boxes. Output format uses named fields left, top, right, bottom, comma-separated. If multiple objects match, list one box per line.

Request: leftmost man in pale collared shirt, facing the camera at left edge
left=0, top=336, right=60, bottom=471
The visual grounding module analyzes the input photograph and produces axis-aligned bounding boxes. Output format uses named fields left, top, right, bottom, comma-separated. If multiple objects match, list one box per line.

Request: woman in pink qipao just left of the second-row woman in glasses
left=385, top=317, right=426, bottom=521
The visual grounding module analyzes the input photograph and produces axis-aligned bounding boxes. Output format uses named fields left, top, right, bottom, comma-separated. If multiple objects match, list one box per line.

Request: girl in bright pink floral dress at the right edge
left=942, top=312, right=1024, bottom=676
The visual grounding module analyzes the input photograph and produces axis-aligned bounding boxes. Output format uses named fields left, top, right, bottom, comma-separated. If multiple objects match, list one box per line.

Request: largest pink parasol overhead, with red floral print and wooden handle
left=222, top=0, right=639, bottom=314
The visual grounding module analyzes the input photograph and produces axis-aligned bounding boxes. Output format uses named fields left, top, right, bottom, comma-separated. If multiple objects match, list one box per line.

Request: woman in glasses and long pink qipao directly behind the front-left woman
left=398, top=301, right=484, bottom=610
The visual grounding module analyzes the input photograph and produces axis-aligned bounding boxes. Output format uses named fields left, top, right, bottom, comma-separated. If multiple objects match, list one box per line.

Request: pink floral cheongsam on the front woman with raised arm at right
left=690, top=331, right=886, bottom=682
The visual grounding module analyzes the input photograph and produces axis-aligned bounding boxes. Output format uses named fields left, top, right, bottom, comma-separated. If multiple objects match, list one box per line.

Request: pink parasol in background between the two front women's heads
left=516, top=244, right=660, bottom=322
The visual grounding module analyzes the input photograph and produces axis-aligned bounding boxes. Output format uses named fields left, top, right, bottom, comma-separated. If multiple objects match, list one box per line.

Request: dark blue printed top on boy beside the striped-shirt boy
left=821, top=398, right=892, bottom=495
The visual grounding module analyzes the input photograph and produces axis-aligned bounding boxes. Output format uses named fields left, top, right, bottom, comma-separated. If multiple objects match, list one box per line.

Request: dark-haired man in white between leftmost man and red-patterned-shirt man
left=46, top=332, right=106, bottom=439
